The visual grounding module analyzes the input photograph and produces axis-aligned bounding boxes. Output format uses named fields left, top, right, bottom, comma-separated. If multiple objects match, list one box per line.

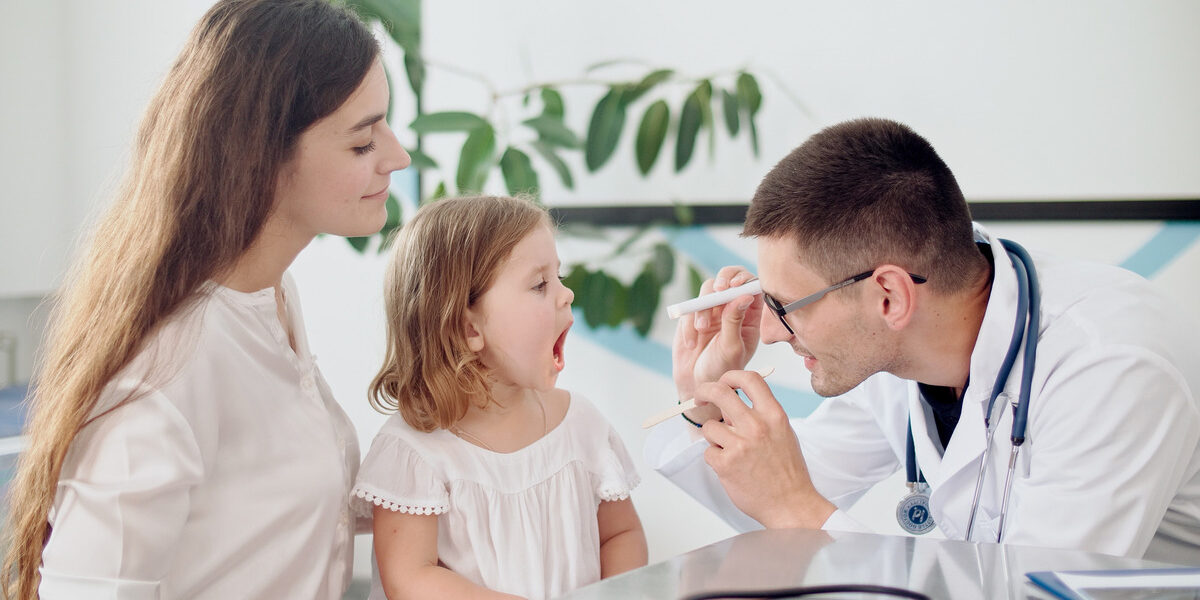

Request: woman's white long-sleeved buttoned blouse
left=40, top=275, right=359, bottom=599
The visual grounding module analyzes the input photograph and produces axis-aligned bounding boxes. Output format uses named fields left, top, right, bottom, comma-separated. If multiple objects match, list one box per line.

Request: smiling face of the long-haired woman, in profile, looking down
left=272, top=59, right=412, bottom=244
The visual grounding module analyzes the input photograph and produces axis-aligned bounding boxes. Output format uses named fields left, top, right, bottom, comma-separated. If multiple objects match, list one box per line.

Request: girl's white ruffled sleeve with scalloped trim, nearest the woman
left=350, top=427, right=450, bottom=517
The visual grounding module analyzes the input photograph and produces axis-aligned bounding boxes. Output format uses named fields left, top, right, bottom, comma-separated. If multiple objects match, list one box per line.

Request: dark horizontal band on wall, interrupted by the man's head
left=550, top=199, right=1200, bottom=226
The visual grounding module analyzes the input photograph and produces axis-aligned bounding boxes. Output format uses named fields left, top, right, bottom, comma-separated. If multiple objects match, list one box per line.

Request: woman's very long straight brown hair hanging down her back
left=0, top=0, right=379, bottom=600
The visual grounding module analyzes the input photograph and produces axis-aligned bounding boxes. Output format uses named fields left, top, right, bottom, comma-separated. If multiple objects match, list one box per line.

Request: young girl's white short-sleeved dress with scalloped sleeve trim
left=354, top=394, right=640, bottom=600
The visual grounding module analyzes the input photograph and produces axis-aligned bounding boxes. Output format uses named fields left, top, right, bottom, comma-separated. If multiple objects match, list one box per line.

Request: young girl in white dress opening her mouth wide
left=354, top=197, right=647, bottom=600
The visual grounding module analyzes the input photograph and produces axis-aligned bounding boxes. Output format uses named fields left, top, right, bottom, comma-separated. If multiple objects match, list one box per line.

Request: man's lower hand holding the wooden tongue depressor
left=696, top=371, right=836, bottom=529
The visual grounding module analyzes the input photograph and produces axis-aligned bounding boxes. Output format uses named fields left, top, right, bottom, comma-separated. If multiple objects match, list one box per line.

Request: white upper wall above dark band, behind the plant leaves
left=425, top=0, right=1200, bottom=203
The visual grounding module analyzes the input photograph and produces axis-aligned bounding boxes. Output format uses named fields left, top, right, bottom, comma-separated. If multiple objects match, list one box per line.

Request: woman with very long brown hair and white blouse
left=4, top=0, right=409, bottom=600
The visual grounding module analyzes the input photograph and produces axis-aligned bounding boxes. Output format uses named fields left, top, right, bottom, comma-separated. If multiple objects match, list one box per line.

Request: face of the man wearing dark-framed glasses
left=758, top=236, right=890, bottom=397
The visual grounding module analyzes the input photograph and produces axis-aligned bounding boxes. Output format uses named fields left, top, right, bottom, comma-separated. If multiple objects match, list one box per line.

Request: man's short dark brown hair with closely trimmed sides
left=742, top=119, right=985, bottom=293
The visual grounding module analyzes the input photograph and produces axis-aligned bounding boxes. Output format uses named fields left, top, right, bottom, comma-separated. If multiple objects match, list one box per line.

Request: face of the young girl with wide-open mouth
left=467, top=226, right=575, bottom=391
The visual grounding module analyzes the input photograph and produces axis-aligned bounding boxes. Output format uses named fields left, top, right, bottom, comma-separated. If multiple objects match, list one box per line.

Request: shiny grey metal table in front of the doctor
left=563, top=529, right=1171, bottom=600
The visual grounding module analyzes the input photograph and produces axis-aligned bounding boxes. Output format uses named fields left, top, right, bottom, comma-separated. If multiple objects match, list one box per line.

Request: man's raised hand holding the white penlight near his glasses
left=671, top=266, right=762, bottom=422
